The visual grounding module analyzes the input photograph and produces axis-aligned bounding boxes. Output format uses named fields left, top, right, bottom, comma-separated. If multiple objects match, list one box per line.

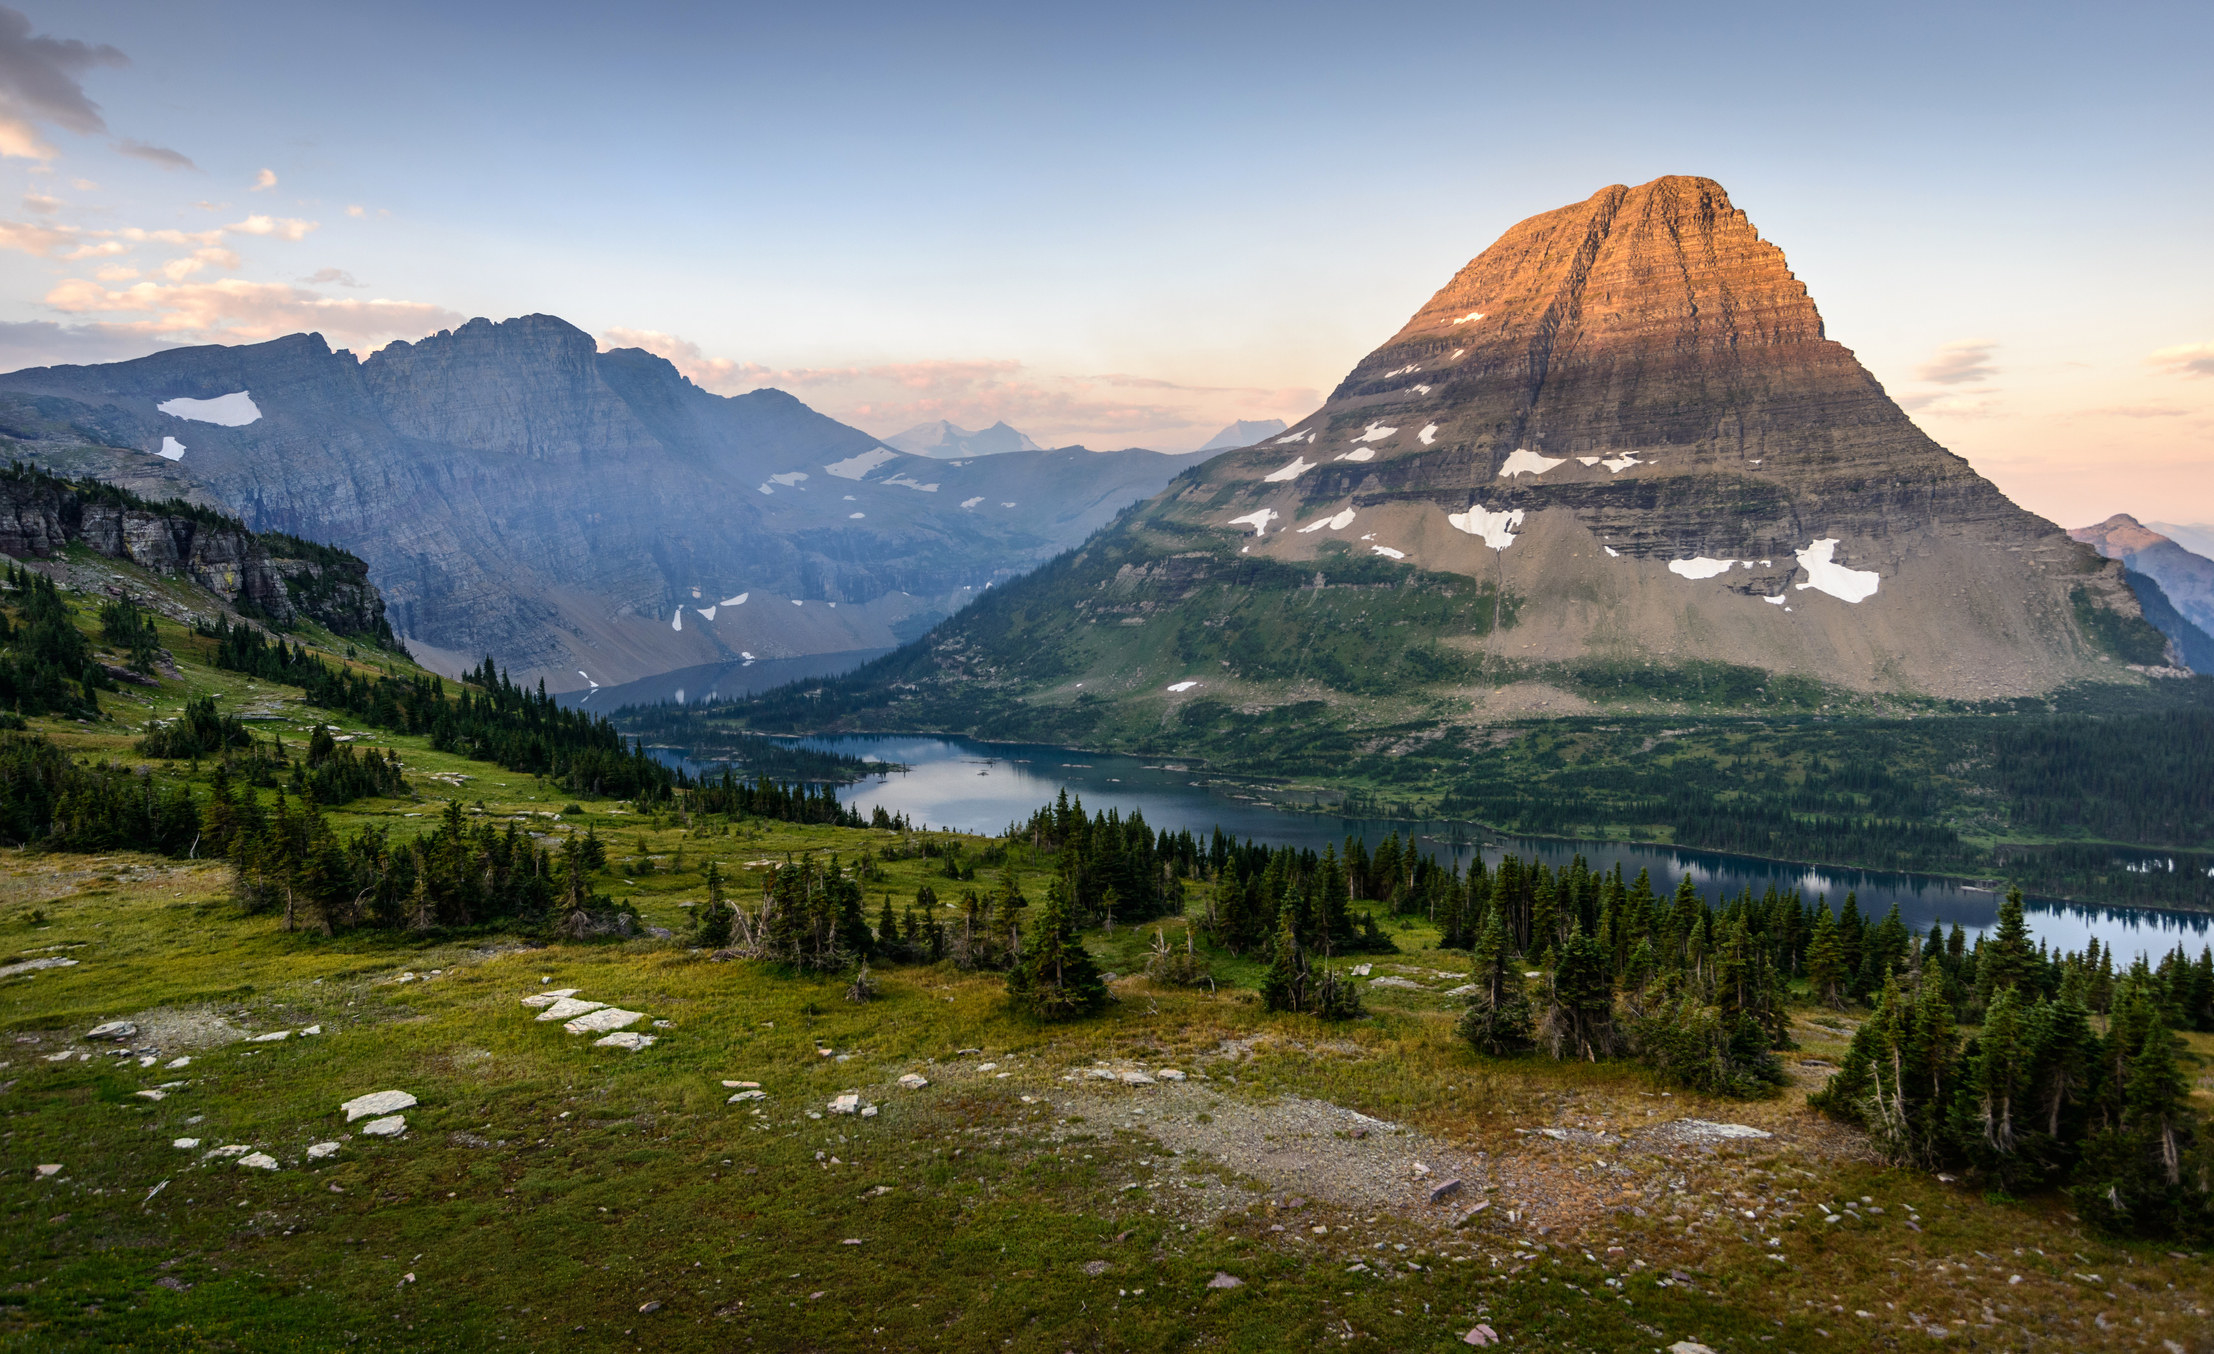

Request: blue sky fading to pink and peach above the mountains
left=0, top=0, right=2214, bottom=527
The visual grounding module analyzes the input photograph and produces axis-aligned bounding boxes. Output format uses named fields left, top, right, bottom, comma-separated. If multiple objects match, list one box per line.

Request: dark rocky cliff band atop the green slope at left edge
left=0, top=471, right=392, bottom=642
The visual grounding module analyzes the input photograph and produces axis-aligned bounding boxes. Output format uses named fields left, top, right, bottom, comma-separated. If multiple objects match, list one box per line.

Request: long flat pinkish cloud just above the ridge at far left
left=46, top=277, right=463, bottom=343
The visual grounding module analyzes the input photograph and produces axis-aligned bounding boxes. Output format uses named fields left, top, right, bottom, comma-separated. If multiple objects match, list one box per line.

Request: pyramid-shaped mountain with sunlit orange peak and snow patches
left=761, top=177, right=2174, bottom=746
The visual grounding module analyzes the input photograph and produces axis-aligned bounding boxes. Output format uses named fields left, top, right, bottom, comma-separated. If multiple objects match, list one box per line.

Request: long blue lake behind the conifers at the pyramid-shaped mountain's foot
left=650, top=735, right=2210, bottom=960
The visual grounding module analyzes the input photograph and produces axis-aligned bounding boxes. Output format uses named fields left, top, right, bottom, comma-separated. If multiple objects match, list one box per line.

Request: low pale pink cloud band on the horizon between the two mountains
left=600, top=330, right=1322, bottom=447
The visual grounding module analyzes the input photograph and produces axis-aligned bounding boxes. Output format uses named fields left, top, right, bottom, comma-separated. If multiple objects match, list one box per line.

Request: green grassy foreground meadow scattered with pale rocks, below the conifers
left=0, top=575, right=2214, bottom=1350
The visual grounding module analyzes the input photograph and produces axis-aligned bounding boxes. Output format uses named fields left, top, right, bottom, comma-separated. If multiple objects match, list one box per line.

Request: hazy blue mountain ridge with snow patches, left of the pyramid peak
left=0, top=314, right=1184, bottom=690
